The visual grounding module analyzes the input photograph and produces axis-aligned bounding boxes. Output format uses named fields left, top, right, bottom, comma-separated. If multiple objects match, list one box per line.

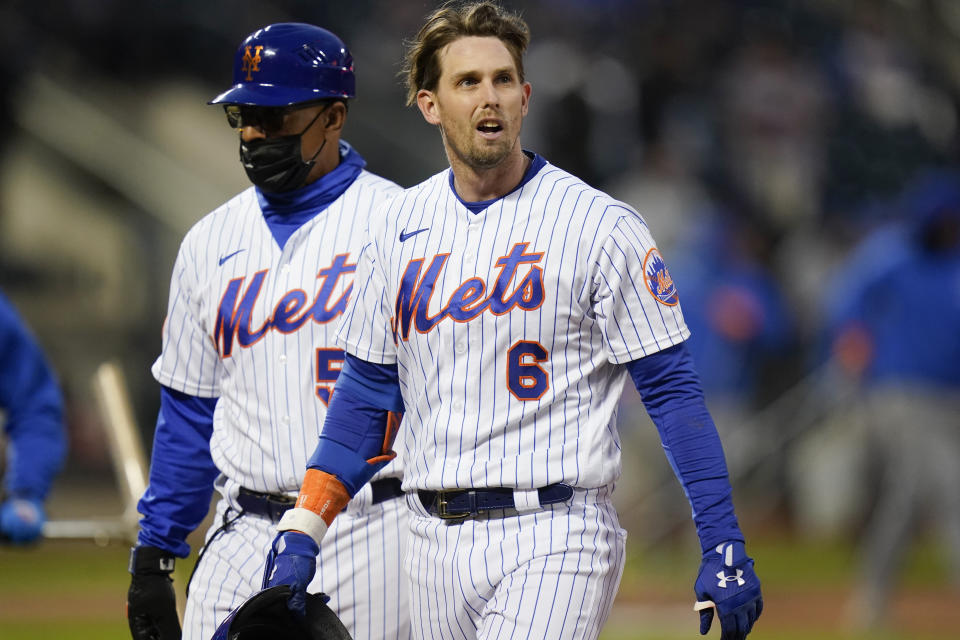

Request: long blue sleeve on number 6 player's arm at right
left=627, top=343, right=743, bottom=552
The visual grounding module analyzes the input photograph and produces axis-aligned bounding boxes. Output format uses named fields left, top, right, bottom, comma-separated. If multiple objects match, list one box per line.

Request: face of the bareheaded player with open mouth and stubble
left=417, top=36, right=530, bottom=170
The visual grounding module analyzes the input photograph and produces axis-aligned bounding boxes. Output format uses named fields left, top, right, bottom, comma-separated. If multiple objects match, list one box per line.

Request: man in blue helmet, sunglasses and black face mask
left=127, top=23, right=409, bottom=640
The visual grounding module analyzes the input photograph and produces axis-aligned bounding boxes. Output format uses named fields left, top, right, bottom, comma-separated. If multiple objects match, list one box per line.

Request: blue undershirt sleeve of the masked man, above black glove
left=137, top=387, right=219, bottom=558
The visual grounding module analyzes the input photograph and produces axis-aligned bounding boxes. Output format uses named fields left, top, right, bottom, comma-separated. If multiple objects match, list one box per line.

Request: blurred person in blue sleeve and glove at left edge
left=0, top=293, right=67, bottom=544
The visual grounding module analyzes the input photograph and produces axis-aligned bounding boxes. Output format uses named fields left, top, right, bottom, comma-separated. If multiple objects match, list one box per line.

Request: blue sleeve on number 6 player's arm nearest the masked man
left=307, top=353, right=403, bottom=497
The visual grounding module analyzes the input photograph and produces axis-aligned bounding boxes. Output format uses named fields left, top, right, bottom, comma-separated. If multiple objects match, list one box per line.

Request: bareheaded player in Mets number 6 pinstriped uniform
left=267, top=2, right=762, bottom=640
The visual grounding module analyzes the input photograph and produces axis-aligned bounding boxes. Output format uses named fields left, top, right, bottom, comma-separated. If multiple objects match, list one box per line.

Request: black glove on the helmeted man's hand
left=127, top=547, right=180, bottom=640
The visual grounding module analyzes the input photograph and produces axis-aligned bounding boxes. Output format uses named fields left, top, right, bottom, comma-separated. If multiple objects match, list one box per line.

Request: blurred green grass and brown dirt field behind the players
left=0, top=539, right=960, bottom=640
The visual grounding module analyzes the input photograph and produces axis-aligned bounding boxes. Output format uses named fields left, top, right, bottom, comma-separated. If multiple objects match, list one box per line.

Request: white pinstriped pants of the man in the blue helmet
left=183, top=485, right=410, bottom=640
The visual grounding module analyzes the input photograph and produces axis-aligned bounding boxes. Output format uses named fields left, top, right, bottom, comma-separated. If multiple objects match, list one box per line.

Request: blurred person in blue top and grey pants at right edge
left=828, top=171, right=960, bottom=626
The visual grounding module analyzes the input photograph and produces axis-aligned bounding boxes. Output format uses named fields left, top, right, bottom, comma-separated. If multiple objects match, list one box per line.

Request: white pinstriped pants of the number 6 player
left=406, top=488, right=627, bottom=640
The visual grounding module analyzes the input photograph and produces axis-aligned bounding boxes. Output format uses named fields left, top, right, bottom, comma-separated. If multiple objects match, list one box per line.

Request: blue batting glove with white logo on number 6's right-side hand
left=693, top=542, right=763, bottom=640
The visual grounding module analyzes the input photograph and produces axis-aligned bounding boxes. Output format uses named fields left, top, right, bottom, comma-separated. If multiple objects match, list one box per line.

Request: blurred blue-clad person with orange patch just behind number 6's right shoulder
left=670, top=210, right=795, bottom=475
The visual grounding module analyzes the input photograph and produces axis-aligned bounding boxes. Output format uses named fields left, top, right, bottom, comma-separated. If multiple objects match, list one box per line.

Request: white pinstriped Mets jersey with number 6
left=338, top=163, right=689, bottom=490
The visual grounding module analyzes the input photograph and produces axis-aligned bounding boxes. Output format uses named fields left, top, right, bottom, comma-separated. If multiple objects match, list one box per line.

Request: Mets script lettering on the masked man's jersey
left=213, top=253, right=357, bottom=358
